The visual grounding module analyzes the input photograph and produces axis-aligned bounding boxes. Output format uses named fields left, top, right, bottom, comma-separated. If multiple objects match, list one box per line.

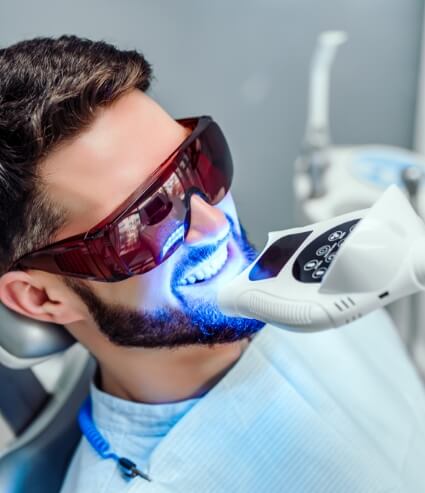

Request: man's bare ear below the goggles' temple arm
left=0, top=271, right=84, bottom=325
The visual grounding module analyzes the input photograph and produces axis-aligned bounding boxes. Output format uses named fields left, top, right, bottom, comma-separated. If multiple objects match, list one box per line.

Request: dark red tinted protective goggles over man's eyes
left=9, top=116, right=233, bottom=282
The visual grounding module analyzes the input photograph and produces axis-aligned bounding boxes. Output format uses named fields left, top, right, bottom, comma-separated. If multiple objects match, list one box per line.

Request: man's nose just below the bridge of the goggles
left=185, top=194, right=230, bottom=245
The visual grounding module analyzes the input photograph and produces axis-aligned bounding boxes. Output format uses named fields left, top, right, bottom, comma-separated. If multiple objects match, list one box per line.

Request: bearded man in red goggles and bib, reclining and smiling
left=0, top=36, right=425, bottom=493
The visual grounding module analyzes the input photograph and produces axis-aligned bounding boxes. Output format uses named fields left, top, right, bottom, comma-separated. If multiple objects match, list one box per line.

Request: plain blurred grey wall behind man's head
left=0, top=0, right=424, bottom=247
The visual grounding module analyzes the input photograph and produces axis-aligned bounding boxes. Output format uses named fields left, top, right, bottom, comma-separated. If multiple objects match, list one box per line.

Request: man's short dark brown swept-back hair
left=0, top=36, right=152, bottom=276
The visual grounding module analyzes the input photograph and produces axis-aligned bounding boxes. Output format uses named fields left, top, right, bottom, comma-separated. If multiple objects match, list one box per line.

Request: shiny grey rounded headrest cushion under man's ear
left=0, top=302, right=75, bottom=368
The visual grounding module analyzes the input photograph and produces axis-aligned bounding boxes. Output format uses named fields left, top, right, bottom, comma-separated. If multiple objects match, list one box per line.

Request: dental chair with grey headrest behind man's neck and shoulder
left=0, top=303, right=95, bottom=493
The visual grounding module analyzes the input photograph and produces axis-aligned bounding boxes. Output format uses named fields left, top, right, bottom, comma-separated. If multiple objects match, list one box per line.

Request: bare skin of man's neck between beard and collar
left=98, top=339, right=249, bottom=404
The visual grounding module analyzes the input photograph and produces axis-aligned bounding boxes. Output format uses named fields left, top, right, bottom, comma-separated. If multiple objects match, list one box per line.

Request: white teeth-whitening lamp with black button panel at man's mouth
left=218, top=185, right=425, bottom=331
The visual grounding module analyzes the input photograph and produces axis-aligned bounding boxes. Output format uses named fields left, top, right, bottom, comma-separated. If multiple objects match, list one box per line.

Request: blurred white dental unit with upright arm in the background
left=293, top=31, right=425, bottom=368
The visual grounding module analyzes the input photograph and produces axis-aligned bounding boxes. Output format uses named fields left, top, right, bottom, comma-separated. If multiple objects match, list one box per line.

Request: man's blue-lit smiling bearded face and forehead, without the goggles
left=42, top=90, right=264, bottom=347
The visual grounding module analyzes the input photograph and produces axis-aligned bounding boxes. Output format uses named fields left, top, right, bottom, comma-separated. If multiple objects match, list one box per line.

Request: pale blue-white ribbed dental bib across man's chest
left=62, top=311, right=425, bottom=493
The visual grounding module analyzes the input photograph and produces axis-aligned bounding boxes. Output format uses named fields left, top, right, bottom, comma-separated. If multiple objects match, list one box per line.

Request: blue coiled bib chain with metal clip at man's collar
left=78, top=396, right=151, bottom=481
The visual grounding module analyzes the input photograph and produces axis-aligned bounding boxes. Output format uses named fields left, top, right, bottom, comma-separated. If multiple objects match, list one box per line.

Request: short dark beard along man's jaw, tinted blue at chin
left=63, top=221, right=265, bottom=348
